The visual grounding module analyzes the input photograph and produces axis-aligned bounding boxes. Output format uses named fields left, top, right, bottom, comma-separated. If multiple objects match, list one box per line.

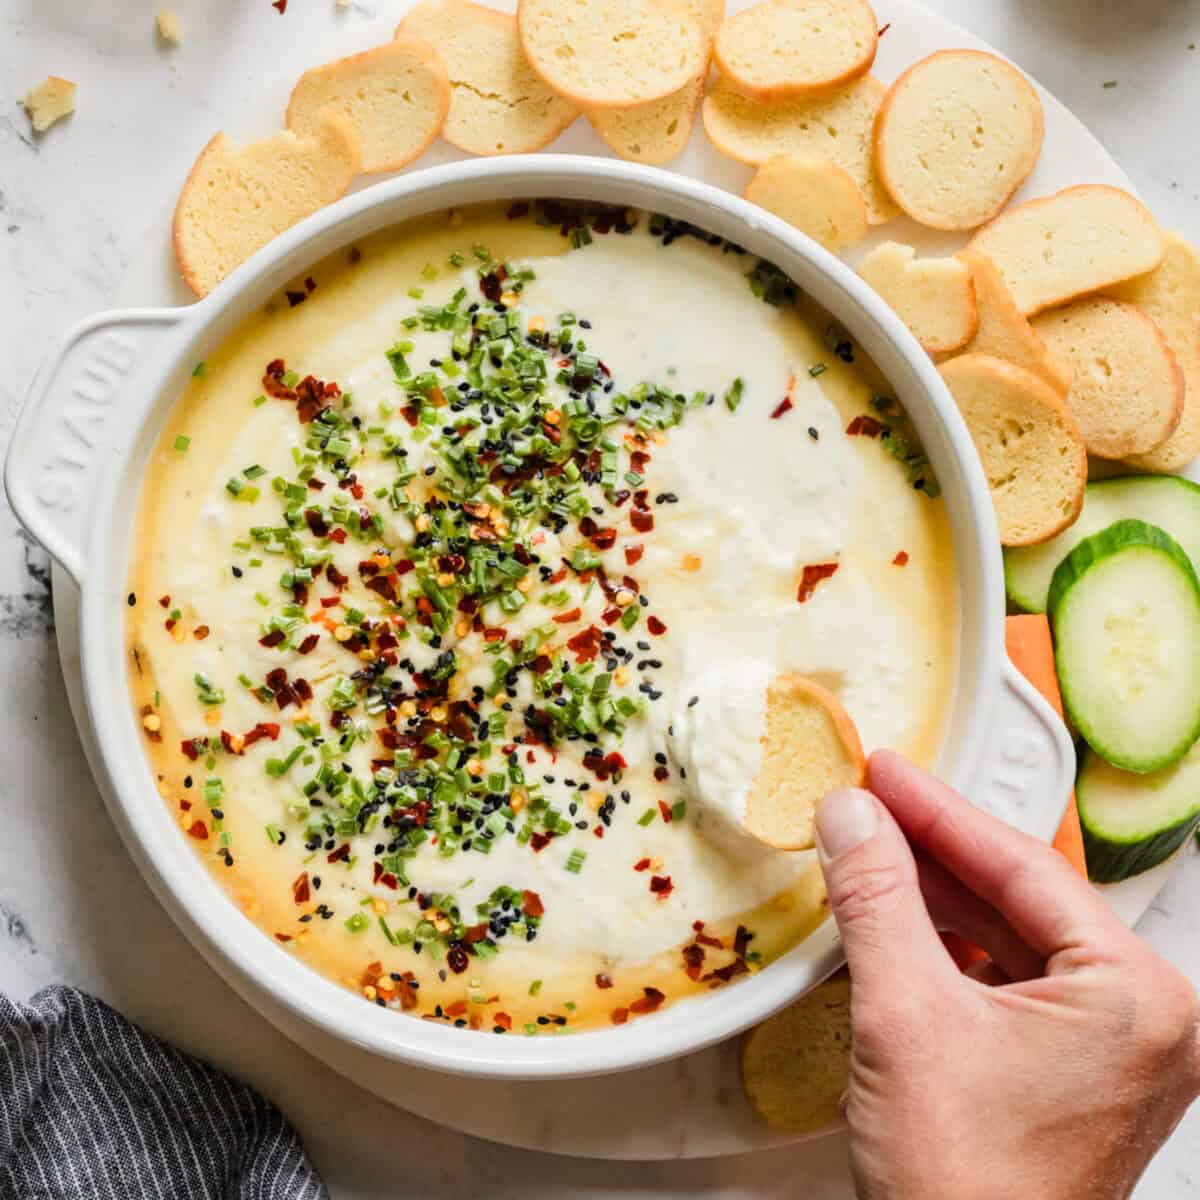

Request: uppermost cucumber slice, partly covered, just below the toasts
left=1004, top=475, right=1200, bottom=612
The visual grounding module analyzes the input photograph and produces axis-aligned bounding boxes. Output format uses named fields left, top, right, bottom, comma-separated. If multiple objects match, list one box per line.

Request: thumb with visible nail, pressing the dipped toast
left=816, top=787, right=958, bottom=1004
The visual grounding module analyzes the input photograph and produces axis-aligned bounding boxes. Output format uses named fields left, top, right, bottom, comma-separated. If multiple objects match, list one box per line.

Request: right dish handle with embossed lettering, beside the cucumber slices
left=967, top=658, right=1075, bottom=841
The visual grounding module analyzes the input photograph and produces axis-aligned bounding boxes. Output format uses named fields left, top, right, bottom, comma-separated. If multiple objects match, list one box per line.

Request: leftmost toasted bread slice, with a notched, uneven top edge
left=172, top=113, right=362, bottom=296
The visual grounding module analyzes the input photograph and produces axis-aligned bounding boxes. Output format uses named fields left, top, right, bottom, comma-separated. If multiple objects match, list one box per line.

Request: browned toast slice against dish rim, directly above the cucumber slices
left=940, top=354, right=1087, bottom=546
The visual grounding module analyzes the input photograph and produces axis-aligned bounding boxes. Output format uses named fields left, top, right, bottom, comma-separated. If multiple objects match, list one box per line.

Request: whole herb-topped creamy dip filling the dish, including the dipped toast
left=127, top=202, right=958, bottom=1037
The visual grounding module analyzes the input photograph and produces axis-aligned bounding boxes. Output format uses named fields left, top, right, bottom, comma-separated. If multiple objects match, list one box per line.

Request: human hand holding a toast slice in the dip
left=817, top=751, right=1200, bottom=1200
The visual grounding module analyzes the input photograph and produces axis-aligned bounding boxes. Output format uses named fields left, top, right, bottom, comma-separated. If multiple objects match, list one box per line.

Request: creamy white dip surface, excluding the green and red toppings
left=131, top=206, right=956, bottom=1027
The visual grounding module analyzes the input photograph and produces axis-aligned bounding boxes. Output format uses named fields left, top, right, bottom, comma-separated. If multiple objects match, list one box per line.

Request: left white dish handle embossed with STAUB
left=4, top=308, right=182, bottom=584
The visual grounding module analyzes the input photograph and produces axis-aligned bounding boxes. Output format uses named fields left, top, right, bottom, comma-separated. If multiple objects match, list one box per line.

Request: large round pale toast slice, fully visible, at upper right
left=875, top=50, right=1043, bottom=229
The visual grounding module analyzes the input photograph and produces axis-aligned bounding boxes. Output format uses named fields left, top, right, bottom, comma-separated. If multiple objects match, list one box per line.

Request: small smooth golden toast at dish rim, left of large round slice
left=743, top=154, right=870, bottom=252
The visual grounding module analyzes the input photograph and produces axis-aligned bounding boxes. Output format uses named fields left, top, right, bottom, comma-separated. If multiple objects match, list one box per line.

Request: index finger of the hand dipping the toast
left=866, top=750, right=1124, bottom=959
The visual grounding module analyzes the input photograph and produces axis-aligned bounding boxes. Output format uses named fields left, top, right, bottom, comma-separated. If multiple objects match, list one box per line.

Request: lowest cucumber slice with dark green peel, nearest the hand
left=1075, top=742, right=1200, bottom=883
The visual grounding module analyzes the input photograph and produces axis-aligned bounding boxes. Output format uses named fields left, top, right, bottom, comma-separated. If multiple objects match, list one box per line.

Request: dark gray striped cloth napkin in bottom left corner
left=0, top=988, right=329, bottom=1200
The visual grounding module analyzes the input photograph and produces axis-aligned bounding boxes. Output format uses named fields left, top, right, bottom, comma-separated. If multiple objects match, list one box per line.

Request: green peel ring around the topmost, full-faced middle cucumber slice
left=1046, top=518, right=1200, bottom=774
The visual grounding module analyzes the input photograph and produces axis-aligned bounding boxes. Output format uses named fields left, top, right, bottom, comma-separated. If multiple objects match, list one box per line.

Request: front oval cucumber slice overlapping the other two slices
left=1049, top=521, right=1200, bottom=774
